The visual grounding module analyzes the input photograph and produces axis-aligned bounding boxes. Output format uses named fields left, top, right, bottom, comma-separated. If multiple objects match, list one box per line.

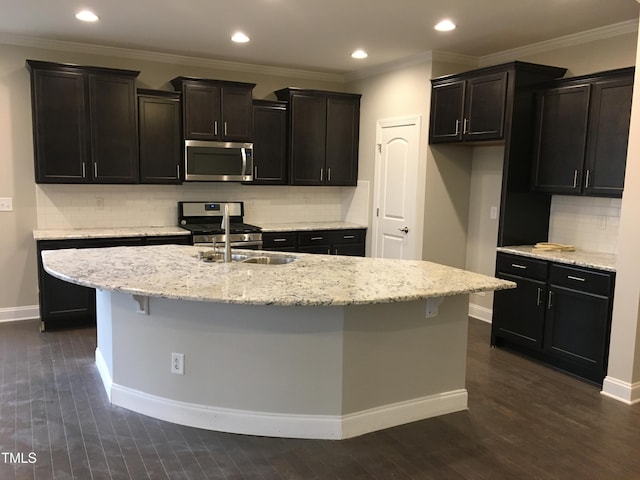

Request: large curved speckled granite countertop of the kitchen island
left=42, top=245, right=515, bottom=306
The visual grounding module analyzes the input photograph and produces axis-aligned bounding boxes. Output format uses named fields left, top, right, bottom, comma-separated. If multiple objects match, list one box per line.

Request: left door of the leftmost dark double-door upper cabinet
left=31, top=69, right=89, bottom=183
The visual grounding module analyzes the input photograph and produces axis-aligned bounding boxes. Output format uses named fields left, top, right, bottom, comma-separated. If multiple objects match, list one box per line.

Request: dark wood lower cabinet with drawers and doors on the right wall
left=491, top=253, right=615, bottom=385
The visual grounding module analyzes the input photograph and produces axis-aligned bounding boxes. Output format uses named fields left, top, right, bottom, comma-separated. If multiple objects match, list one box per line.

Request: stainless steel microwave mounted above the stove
left=184, top=140, right=253, bottom=182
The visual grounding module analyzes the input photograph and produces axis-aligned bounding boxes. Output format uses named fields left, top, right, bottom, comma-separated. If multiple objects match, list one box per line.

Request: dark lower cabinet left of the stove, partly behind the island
left=37, top=235, right=191, bottom=331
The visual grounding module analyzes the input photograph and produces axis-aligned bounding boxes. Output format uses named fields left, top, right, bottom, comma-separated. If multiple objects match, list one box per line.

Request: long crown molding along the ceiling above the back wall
left=0, top=32, right=345, bottom=83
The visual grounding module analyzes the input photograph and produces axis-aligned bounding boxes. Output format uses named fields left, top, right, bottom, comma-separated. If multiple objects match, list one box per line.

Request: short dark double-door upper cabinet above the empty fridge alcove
left=429, top=69, right=508, bottom=143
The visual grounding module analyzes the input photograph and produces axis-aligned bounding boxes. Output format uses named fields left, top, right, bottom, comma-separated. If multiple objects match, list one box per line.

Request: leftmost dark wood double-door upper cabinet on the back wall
left=26, top=60, right=139, bottom=183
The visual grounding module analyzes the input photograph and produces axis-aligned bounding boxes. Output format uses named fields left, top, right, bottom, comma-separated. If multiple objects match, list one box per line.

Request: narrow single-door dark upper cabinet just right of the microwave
left=253, top=102, right=287, bottom=185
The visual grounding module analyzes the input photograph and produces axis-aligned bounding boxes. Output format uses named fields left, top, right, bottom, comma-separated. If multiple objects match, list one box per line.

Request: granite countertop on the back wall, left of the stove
left=33, top=226, right=191, bottom=240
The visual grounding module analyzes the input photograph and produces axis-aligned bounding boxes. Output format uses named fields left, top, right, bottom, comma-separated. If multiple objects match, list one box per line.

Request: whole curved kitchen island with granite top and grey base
left=42, top=245, right=513, bottom=439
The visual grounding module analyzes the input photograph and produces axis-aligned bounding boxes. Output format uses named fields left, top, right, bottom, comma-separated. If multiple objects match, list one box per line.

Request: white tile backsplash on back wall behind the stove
left=36, top=182, right=369, bottom=229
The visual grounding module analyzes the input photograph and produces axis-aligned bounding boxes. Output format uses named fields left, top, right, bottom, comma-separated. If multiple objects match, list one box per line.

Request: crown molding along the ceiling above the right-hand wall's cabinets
left=479, top=19, right=640, bottom=66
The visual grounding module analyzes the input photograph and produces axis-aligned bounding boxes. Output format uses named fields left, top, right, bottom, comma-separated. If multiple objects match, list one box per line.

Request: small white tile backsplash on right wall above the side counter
left=549, top=195, right=622, bottom=253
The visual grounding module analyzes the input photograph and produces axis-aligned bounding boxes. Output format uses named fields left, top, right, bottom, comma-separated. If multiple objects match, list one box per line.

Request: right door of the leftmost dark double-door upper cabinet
left=89, top=75, right=139, bottom=183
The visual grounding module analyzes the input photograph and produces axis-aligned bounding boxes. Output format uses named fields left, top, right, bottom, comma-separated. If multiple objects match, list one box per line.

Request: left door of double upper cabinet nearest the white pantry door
left=289, top=95, right=327, bottom=185
